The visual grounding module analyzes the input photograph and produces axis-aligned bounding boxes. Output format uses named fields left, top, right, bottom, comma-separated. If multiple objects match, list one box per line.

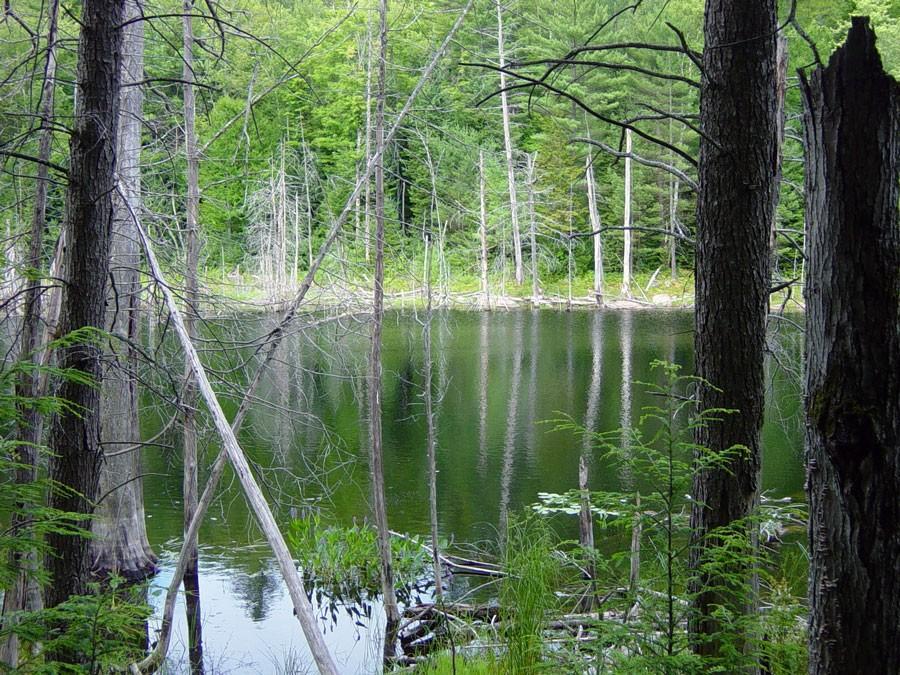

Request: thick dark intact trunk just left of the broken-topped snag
left=690, top=0, right=777, bottom=656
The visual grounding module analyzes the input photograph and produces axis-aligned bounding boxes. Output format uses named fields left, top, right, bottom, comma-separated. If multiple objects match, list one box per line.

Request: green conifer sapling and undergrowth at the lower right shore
left=535, top=362, right=806, bottom=674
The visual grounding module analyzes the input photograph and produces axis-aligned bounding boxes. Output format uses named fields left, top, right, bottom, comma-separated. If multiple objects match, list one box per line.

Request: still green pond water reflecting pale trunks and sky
left=144, top=310, right=803, bottom=673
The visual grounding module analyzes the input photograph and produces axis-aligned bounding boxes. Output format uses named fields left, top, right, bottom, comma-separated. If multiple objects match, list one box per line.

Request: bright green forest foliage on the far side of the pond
left=0, top=0, right=872, bottom=302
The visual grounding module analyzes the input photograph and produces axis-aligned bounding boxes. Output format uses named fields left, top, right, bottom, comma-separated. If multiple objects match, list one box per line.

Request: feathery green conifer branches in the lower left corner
left=0, top=346, right=150, bottom=673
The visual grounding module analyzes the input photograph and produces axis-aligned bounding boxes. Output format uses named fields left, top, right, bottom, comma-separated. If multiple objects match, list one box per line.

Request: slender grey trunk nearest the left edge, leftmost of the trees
left=0, top=0, right=59, bottom=668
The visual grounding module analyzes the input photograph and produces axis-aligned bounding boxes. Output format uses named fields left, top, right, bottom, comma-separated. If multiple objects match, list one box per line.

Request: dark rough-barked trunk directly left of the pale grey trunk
left=46, top=0, right=125, bottom=612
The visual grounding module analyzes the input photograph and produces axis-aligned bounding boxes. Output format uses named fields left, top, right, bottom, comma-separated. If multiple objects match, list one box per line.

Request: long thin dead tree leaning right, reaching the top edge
left=130, top=0, right=474, bottom=673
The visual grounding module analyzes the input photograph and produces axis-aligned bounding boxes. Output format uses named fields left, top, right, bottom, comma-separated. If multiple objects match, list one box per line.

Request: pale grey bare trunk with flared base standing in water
left=93, top=0, right=156, bottom=581
